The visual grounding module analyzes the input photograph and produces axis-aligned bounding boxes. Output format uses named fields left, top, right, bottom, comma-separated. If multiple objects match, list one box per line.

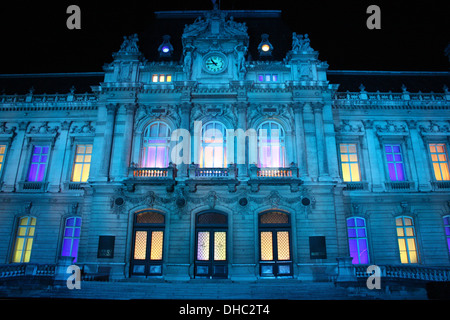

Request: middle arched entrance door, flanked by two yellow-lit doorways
left=195, top=212, right=228, bottom=278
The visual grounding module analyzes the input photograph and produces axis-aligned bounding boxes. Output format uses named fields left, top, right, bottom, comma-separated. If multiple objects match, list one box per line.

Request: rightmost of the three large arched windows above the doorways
left=258, top=121, right=286, bottom=168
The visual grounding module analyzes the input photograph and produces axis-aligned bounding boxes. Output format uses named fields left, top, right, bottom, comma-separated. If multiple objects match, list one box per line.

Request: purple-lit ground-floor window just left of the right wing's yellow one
left=347, top=217, right=369, bottom=264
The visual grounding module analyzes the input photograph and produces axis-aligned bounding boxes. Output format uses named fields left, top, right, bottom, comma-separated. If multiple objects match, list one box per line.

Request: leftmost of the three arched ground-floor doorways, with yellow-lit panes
left=130, top=211, right=165, bottom=276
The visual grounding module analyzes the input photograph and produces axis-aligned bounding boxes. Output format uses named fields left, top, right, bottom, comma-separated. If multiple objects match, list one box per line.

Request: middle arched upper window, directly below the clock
left=199, top=121, right=227, bottom=168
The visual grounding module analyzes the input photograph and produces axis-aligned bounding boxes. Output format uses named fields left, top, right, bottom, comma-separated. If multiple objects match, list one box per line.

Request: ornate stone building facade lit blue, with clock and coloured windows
left=0, top=9, right=450, bottom=281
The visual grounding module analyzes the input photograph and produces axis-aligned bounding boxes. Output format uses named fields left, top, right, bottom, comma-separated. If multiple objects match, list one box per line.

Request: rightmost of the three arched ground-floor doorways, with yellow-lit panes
left=258, top=210, right=292, bottom=277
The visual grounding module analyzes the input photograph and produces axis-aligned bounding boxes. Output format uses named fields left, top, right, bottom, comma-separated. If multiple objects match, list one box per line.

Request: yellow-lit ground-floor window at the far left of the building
left=12, top=217, right=36, bottom=263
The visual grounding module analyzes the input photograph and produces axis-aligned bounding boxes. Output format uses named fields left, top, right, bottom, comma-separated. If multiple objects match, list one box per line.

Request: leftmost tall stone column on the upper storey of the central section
left=97, top=104, right=118, bottom=181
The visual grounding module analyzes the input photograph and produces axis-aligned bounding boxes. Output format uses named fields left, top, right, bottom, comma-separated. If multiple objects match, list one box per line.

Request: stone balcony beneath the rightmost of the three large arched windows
left=249, top=163, right=303, bottom=192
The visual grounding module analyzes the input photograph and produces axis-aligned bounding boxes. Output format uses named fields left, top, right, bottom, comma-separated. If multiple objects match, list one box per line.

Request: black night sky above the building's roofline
left=0, top=0, right=450, bottom=73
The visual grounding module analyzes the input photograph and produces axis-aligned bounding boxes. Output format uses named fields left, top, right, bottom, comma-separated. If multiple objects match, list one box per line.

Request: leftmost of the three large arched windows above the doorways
left=140, top=121, right=171, bottom=168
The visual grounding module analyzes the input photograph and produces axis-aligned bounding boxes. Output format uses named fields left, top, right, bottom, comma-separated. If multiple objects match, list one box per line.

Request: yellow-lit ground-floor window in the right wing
left=395, top=217, right=419, bottom=263
